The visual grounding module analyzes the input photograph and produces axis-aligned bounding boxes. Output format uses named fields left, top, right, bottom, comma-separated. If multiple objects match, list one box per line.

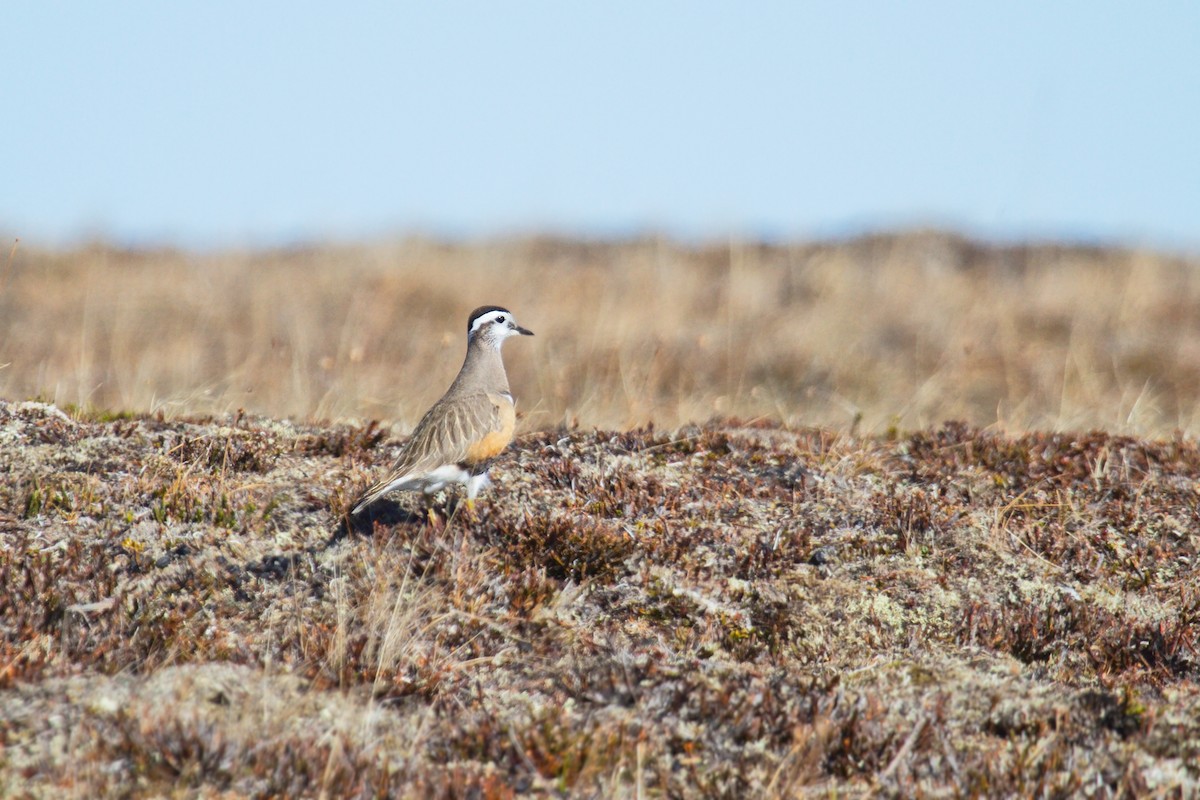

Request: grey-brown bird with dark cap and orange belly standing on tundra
left=352, top=306, right=533, bottom=515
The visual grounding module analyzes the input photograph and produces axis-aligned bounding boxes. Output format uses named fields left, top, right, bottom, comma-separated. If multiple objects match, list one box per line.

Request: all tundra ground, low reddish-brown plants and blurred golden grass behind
left=0, top=234, right=1200, bottom=798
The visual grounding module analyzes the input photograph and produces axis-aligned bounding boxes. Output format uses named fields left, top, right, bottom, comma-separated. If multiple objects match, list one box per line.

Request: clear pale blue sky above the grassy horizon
left=0, top=1, right=1200, bottom=249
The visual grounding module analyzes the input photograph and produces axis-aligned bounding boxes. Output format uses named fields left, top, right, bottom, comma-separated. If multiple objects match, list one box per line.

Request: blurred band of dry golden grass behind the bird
left=7, top=227, right=1200, bottom=435
